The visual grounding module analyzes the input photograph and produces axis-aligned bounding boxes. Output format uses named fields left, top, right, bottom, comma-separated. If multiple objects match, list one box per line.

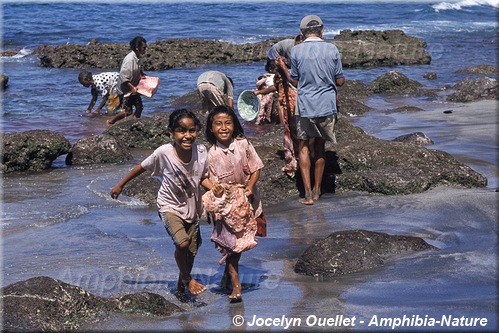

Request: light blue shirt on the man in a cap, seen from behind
left=290, top=37, right=343, bottom=118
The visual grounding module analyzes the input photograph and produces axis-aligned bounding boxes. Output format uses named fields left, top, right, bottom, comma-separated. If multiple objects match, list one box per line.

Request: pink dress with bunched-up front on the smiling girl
left=203, top=138, right=263, bottom=255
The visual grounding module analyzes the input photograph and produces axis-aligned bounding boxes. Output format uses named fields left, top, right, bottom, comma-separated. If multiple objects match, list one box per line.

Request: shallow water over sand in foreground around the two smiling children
left=3, top=100, right=497, bottom=331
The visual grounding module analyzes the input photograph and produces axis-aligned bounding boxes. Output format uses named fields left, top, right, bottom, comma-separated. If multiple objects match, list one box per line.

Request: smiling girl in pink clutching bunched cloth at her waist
left=203, top=106, right=266, bottom=302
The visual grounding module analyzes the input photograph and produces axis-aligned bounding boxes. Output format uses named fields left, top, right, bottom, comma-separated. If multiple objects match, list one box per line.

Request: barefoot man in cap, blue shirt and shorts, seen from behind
left=280, top=15, right=345, bottom=205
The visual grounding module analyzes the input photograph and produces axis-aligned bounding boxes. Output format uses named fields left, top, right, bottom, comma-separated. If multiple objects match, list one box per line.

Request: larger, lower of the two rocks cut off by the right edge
left=447, top=77, right=499, bottom=102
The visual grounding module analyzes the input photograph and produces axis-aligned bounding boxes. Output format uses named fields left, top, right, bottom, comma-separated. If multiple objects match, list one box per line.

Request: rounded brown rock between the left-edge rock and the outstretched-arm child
left=66, top=134, right=132, bottom=165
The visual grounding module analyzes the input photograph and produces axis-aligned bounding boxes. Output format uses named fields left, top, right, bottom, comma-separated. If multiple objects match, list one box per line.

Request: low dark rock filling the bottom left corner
left=2, top=276, right=183, bottom=332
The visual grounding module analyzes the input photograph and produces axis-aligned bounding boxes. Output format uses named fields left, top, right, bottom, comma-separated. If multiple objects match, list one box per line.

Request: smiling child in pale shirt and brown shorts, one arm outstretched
left=111, top=109, right=222, bottom=298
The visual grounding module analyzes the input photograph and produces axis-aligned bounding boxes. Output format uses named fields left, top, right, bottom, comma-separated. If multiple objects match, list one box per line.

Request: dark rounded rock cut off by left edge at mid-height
left=0, top=130, right=71, bottom=173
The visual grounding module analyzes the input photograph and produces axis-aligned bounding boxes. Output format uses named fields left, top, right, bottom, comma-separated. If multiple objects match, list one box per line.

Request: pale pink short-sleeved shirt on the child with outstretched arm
left=141, top=142, right=209, bottom=223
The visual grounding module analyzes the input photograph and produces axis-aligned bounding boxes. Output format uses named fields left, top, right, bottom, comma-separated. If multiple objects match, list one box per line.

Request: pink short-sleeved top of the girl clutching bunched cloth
left=208, top=138, right=264, bottom=217
